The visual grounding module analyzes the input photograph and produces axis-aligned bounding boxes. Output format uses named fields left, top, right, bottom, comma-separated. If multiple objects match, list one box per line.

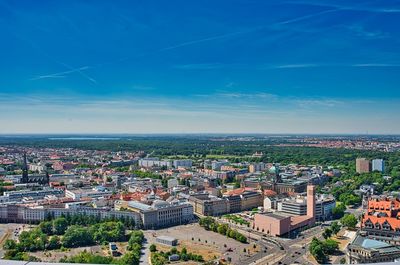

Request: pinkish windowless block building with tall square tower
left=253, top=185, right=316, bottom=237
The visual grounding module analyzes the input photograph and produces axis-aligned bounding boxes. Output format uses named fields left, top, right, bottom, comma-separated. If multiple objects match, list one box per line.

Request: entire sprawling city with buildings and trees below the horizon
left=0, top=135, right=400, bottom=264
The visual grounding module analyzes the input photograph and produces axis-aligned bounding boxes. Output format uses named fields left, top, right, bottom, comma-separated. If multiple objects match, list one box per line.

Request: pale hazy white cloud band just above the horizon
left=0, top=93, right=400, bottom=133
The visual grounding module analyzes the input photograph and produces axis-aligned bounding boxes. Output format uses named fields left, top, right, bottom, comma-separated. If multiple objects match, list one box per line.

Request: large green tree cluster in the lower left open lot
left=4, top=215, right=144, bottom=264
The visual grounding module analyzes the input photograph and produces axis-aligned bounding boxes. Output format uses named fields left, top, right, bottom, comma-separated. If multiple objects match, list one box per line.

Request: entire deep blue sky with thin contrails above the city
left=0, top=0, right=400, bottom=134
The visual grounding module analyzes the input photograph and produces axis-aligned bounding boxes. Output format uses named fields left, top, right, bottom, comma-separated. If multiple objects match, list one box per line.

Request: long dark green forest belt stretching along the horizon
left=4, top=135, right=400, bottom=170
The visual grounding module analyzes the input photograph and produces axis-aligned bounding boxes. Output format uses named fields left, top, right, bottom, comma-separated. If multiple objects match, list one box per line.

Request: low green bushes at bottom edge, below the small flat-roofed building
left=150, top=244, right=204, bottom=265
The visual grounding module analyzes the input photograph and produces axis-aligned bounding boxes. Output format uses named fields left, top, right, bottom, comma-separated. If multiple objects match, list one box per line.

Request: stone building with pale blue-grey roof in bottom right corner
left=347, top=233, right=400, bottom=264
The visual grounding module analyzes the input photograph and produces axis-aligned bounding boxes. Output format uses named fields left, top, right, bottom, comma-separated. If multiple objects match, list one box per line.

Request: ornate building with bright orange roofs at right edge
left=361, top=196, right=400, bottom=244
